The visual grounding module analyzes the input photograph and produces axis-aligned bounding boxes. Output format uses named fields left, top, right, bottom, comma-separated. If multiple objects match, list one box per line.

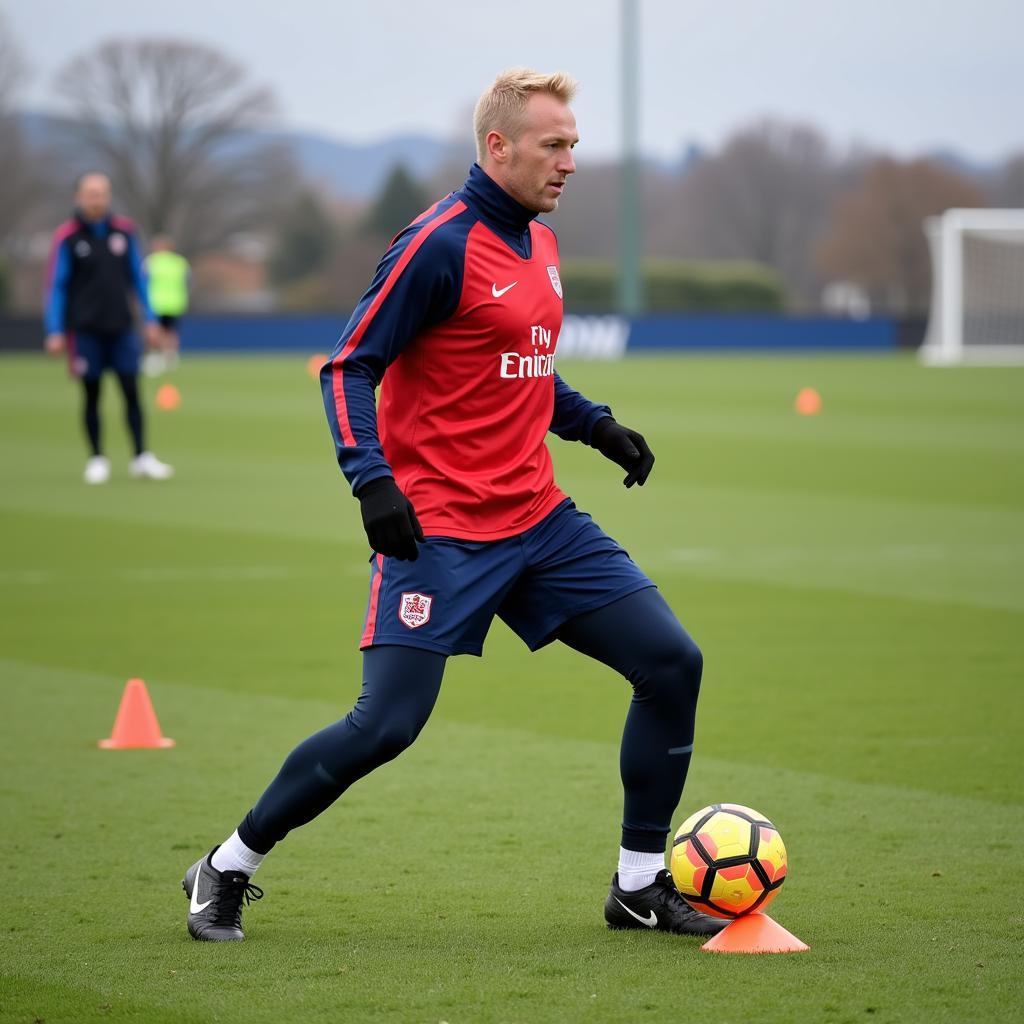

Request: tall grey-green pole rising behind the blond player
left=618, top=0, right=643, bottom=316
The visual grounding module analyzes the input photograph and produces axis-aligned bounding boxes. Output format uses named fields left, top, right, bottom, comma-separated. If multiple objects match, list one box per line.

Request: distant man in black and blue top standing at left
left=45, top=172, right=174, bottom=483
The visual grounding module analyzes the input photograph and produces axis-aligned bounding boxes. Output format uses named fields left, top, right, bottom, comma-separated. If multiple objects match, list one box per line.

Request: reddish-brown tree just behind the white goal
left=818, top=158, right=984, bottom=315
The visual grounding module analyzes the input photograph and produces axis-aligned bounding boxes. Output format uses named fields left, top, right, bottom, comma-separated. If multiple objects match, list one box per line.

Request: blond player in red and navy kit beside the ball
left=182, top=70, right=723, bottom=941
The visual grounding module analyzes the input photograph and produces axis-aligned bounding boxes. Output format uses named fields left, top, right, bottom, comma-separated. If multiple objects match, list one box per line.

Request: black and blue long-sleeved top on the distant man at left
left=44, top=211, right=156, bottom=335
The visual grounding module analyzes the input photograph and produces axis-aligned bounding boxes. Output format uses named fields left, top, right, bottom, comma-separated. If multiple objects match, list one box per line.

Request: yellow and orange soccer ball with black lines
left=671, top=804, right=786, bottom=918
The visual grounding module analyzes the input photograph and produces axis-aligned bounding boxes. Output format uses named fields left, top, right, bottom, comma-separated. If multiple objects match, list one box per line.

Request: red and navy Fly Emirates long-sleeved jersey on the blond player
left=321, top=164, right=611, bottom=541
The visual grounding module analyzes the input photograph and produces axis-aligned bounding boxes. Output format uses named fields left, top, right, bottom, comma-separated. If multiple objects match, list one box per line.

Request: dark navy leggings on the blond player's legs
left=239, top=587, right=703, bottom=853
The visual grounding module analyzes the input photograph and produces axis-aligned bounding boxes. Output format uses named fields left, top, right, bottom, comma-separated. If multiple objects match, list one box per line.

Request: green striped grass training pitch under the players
left=0, top=357, right=1024, bottom=1024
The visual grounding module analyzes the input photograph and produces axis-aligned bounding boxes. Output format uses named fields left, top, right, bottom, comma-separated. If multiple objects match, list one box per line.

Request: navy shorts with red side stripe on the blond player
left=359, top=500, right=654, bottom=654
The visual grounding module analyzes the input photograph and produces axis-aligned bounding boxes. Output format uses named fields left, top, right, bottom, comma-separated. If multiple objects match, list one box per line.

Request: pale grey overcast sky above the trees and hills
left=0, top=0, right=1024, bottom=160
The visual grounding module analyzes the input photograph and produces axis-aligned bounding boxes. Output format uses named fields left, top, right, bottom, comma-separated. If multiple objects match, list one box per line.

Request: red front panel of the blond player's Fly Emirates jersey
left=378, top=222, right=564, bottom=540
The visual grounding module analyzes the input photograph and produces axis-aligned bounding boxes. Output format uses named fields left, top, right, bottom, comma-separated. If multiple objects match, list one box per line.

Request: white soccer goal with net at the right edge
left=921, top=210, right=1024, bottom=365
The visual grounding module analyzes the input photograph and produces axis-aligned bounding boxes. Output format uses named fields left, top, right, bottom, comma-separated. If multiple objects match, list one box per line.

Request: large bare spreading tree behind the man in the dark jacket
left=56, top=39, right=289, bottom=254
